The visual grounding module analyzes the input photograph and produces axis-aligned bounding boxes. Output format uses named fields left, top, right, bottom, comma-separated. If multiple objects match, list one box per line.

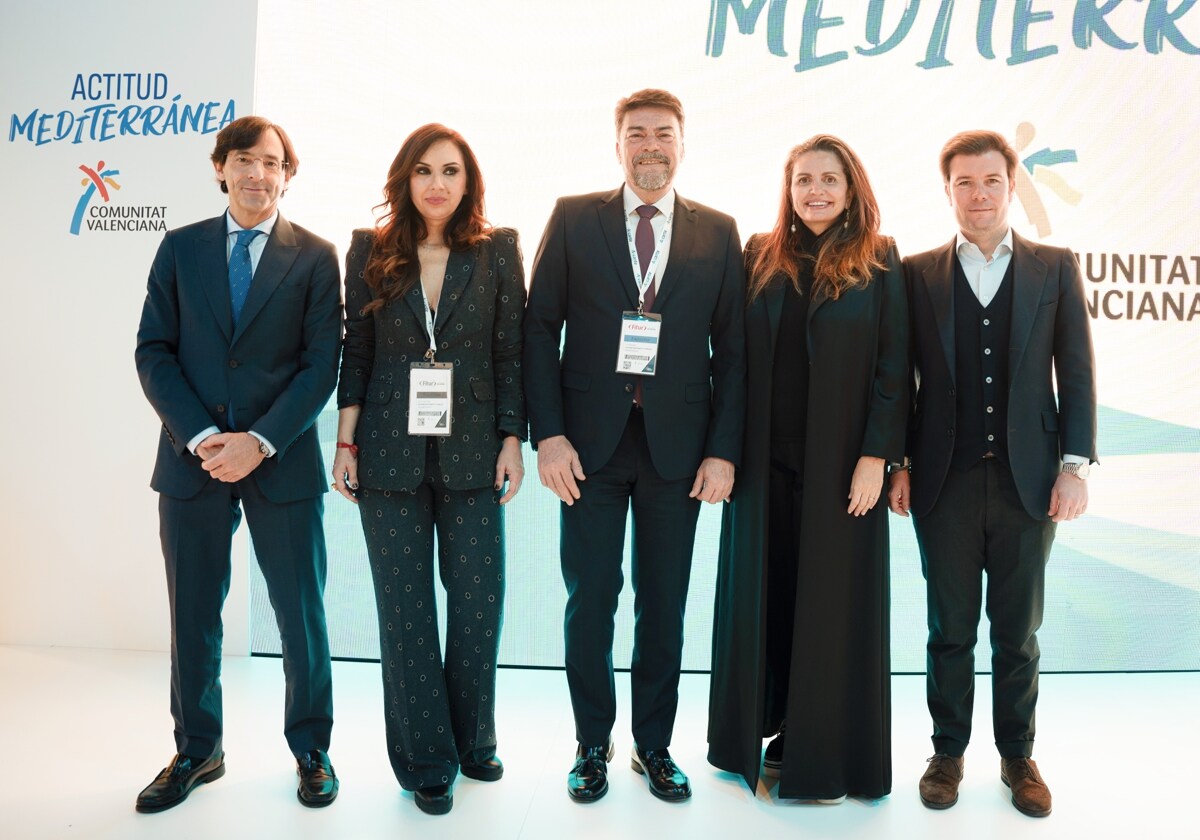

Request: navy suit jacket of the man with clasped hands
left=134, top=214, right=341, bottom=503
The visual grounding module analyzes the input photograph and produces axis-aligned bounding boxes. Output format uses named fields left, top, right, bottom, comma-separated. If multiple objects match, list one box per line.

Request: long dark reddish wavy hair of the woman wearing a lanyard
left=362, top=122, right=491, bottom=314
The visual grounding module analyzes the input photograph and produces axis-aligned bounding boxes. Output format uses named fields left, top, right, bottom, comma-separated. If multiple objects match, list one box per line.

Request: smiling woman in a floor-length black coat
left=708, top=134, right=908, bottom=802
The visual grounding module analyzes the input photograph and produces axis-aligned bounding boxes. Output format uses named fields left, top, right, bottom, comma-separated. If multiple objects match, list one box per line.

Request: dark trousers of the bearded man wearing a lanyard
left=560, top=409, right=700, bottom=750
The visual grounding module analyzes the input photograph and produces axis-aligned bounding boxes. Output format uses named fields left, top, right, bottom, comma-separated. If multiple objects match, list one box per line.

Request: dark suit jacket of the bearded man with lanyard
left=524, top=188, right=745, bottom=480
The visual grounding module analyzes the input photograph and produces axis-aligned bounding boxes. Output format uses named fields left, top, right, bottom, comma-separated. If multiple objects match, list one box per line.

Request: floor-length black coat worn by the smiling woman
left=708, top=235, right=908, bottom=798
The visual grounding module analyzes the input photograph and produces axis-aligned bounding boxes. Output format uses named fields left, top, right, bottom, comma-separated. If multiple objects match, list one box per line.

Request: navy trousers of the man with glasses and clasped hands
left=158, top=478, right=334, bottom=758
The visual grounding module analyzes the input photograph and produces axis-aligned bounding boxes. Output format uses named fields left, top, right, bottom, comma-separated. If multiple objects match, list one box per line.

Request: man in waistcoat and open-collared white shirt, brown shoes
left=889, top=131, right=1096, bottom=817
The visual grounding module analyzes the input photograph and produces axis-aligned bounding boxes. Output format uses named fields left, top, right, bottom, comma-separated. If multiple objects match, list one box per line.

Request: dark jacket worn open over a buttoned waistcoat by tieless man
left=904, top=232, right=1096, bottom=520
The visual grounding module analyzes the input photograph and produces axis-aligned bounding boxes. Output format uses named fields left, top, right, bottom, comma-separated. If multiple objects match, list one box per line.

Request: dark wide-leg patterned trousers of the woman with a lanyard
left=359, top=462, right=504, bottom=791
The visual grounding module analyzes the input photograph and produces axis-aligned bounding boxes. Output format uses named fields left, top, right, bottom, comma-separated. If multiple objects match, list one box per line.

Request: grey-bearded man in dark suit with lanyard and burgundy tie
left=523, top=90, right=745, bottom=802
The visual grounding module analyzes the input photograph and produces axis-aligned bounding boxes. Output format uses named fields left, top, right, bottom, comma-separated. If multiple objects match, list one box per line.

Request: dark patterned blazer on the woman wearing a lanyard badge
left=337, top=228, right=526, bottom=492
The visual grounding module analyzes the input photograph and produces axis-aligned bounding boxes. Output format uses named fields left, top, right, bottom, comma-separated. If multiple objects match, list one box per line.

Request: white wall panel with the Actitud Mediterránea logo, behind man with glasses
left=0, top=0, right=257, bottom=649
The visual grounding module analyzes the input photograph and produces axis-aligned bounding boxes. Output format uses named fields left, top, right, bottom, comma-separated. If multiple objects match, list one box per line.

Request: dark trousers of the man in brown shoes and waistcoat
left=914, top=458, right=1055, bottom=758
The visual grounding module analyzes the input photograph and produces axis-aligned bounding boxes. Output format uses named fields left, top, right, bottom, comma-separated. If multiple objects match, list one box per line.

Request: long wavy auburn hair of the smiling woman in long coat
left=748, top=134, right=887, bottom=300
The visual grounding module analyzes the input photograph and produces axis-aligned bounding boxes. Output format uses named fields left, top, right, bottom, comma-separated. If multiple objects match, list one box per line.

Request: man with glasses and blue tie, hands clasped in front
left=136, top=116, right=341, bottom=811
